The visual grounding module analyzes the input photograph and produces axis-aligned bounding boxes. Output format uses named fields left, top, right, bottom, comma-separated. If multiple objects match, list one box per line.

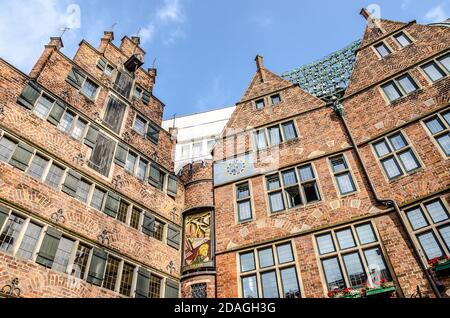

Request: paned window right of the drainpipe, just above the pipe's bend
left=373, top=132, right=421, bottom=180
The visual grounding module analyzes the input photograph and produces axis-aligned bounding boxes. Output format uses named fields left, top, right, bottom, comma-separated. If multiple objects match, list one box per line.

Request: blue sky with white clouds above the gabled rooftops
left=0, top=0, right=450, bottom=118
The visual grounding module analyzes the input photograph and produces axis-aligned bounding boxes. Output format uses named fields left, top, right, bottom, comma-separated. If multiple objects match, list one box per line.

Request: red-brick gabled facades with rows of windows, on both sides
left=0, top=10, right=450, bottom=298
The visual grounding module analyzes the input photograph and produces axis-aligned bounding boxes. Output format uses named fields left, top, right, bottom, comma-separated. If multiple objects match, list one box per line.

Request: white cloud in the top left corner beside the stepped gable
left=0, top=0, right=80, bottom=72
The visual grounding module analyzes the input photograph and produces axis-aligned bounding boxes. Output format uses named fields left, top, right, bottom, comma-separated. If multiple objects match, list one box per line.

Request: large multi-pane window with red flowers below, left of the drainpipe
left=316, top=223, right=392, bottom=291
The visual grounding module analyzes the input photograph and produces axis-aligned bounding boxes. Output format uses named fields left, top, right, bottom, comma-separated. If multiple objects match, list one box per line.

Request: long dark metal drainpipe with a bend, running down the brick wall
left=329, top=96, right=442, bottom=298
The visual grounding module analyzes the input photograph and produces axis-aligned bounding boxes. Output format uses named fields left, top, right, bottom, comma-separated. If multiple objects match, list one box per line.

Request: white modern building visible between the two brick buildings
left=162, top=106, right=236, bottom=173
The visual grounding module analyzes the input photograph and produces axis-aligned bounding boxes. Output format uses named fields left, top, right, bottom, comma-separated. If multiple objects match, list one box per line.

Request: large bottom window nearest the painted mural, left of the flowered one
left=239, top=243, right=300, bottom=298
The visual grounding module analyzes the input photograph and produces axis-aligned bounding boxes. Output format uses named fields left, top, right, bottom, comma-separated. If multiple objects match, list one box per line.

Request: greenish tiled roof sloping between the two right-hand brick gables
left=281, top=40, right=361, bottom=98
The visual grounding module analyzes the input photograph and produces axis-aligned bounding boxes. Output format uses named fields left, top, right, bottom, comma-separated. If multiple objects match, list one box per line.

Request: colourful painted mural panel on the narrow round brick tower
left=183, top=211, right=214, bottom=271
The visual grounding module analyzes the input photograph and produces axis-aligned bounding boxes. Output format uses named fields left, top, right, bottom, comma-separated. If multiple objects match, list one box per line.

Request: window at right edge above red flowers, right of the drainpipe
left=405, top=198, right=450, bottom=260
